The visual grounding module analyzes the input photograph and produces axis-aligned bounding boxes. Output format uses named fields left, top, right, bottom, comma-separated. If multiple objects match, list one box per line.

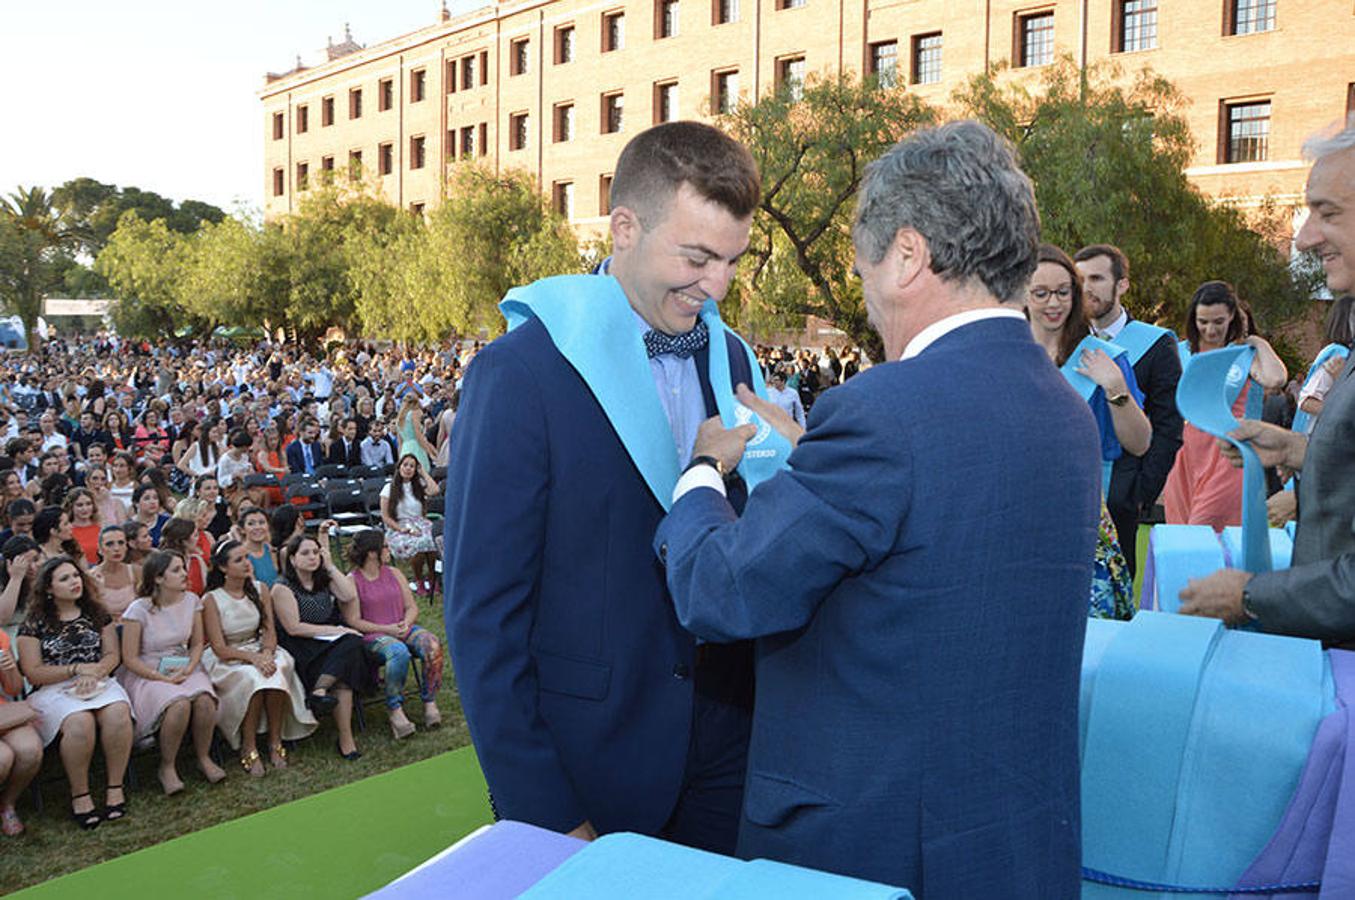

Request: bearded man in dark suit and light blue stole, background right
left=1073, top=244, right=1183, bottom=575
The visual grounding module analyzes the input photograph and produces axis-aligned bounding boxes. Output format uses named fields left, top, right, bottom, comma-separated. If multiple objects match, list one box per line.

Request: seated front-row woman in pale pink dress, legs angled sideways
left=118, top=550, right=226, bottom=794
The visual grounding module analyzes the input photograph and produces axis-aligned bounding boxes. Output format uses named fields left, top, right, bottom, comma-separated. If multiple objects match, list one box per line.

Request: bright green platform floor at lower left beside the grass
left=12, top=747, right=491, bottom=900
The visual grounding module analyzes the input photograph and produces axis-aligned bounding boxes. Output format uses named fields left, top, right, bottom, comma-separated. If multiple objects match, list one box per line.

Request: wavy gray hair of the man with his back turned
left=852, top=121, right=1039, bottom=302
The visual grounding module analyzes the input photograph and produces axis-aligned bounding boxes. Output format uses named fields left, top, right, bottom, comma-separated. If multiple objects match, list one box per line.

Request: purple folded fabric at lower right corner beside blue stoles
left=1232, top=651, right=1355, bottom=900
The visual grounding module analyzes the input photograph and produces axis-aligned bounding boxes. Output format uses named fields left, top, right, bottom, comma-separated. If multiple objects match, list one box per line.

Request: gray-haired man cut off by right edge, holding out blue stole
left=1182, top=115, right=1355, bottom=649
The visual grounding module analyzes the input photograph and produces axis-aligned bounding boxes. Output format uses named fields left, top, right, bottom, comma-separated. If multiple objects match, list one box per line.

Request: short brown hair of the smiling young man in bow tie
left=611, top=122, right=762, bottom=228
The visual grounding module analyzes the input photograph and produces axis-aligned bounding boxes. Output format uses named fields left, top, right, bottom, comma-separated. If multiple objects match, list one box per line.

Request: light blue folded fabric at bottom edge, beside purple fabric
left=522, top=834, right=912, bottom=900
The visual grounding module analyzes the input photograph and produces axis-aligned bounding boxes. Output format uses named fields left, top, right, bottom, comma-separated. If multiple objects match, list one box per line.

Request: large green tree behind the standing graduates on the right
left=955, top=57, right=1310, bottom=333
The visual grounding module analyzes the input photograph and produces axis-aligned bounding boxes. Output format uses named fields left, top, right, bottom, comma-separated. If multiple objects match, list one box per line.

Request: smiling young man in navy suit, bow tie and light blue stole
left=444, top=122, right=759, bottom=853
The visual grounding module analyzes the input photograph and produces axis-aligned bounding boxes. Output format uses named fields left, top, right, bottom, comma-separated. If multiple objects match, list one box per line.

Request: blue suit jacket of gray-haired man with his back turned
left=656, top=319, right=1100, bottom=900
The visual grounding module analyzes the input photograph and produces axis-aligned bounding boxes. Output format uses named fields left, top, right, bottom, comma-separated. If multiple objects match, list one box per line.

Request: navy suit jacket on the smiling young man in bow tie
left=444, top=314, right=752, bottom=835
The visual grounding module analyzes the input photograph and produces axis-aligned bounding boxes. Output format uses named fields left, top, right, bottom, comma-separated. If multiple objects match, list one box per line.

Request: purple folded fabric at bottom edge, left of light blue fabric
left=369, top=821, right=588, bottom=900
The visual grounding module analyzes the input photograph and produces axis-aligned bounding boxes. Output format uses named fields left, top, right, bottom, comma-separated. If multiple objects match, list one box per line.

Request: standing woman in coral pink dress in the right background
left=1163, top=281, right=1289, bottom=531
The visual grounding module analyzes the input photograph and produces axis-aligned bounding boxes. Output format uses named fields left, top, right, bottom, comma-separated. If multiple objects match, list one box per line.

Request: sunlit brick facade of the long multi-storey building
left=260, top=0, right=1355, bottom=220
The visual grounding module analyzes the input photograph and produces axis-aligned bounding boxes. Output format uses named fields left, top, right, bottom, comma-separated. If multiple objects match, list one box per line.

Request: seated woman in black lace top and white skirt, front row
left=18, top=557, right=131, bottom=828
